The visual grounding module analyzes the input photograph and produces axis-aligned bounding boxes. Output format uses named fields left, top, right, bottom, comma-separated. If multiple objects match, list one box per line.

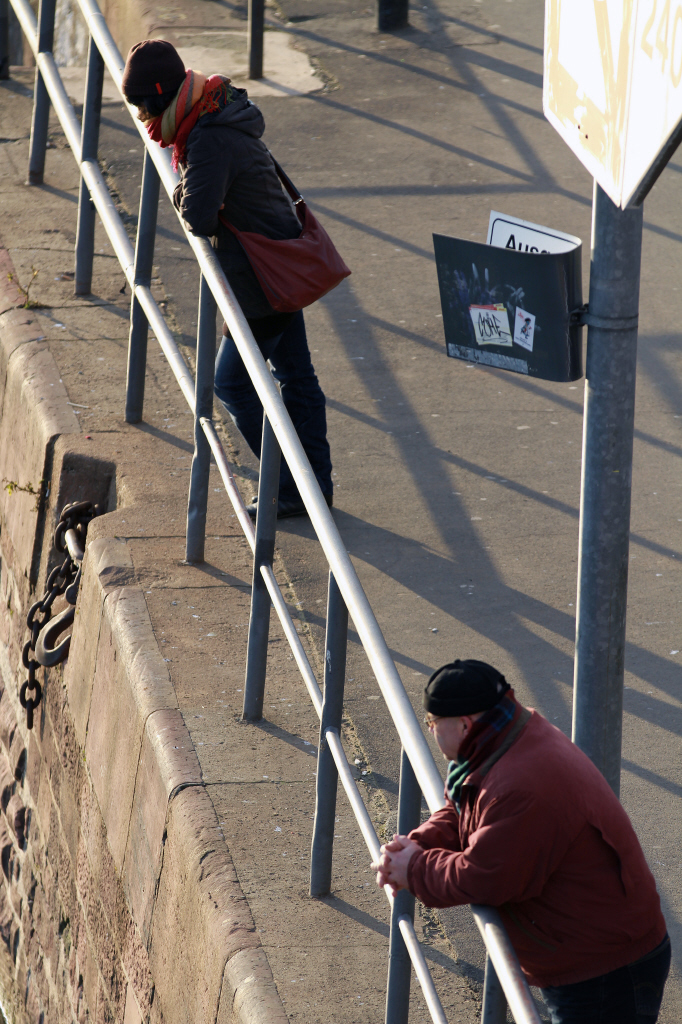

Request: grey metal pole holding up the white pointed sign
left=572, top=182, right=643, bottom=795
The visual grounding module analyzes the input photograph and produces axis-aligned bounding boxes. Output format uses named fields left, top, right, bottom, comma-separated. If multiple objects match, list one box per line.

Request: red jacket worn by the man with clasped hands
left=408, top=712, right=666, bottom=987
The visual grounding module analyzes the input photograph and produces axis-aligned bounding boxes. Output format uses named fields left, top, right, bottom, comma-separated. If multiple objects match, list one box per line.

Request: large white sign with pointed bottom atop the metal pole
left=543, top=0, right=682, bottom=209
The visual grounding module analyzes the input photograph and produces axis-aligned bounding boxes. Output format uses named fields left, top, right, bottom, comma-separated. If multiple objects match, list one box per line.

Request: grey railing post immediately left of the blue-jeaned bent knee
left=184, top=274, right=217, bottom=562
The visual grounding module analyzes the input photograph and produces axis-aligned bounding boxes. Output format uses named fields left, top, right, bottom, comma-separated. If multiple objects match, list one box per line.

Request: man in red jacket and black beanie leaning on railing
left=373, top=660, right=670, bottom=1024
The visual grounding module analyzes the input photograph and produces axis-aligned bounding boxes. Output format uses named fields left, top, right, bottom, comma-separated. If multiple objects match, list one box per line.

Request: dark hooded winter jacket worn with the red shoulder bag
left=174, top=86, right=301, bottom=318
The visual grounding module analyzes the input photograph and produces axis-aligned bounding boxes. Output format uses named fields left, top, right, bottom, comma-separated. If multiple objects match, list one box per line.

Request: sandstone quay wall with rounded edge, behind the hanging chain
left=0, top=250, right=286, bottom=1024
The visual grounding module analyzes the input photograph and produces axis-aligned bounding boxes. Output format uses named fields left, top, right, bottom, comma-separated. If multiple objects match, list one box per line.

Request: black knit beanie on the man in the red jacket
left=424, top=658, right=511, bottom=718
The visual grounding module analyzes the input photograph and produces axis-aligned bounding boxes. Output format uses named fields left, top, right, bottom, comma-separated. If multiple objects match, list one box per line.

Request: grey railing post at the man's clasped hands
left=386, top=751, right=422, bottom=1024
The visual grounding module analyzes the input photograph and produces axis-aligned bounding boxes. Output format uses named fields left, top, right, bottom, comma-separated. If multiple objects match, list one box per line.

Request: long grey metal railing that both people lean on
left=0, top=0, right=540, bottom=1024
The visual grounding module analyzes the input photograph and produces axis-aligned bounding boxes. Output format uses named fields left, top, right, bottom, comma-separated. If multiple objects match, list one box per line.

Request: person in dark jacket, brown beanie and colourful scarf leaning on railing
left=122, top=39, right=333, bottom=518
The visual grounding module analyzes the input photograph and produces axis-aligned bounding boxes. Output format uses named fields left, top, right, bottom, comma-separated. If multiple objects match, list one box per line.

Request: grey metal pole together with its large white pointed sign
left=544, top=0, right=682, bottom=794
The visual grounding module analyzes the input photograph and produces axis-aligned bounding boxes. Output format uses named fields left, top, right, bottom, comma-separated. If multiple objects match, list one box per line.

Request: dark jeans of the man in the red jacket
left=542, top=936, right=670, bottom=1024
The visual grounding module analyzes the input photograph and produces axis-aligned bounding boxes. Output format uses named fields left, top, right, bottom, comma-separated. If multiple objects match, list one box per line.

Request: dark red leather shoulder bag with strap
left=219, top=158, right=350, bottom=313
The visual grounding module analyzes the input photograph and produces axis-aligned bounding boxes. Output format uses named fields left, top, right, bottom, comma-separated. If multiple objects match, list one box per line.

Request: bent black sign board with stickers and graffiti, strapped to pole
left=433, top=234, right=583, bottom=381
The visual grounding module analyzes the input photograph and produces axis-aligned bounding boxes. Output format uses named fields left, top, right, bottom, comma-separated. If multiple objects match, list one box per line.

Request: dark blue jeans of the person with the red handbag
left=210, top=311, right=334, bottom=501
